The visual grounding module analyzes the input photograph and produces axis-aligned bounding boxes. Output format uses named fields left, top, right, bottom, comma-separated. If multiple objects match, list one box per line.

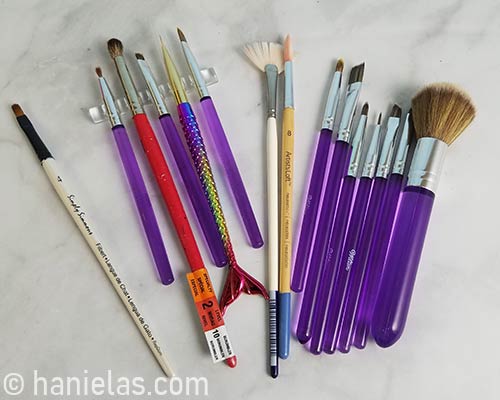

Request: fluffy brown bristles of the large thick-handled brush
left=411, top=83, right=476, bottom=146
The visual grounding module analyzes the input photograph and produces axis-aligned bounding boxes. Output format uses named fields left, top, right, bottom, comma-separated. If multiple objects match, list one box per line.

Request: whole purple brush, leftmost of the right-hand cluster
left=291, top=59, right=344, bottom=292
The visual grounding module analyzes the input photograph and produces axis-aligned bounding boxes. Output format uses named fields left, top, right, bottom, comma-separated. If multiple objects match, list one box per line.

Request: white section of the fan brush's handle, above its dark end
left=267, top=117, right=279, bottom=291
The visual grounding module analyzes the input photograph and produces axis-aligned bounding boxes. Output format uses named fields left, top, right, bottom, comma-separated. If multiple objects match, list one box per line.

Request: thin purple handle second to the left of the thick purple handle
left=337, top=178, right=387, bottom=353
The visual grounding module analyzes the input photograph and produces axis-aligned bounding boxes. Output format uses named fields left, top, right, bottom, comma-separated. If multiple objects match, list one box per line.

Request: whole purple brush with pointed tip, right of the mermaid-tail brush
left=177, top=28, right=264, bottom=248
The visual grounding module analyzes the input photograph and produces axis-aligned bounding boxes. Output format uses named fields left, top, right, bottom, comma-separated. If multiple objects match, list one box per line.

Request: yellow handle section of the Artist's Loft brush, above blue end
left=279, top=107, right=295, bottom=293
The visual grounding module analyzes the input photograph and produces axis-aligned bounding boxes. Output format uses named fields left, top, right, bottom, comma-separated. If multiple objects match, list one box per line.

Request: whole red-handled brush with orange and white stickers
left=108, top=39, right=236, bottom=367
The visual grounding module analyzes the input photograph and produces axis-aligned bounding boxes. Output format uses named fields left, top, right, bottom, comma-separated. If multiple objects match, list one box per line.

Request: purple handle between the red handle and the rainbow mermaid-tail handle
left=160, top=114, right=227, bottom=267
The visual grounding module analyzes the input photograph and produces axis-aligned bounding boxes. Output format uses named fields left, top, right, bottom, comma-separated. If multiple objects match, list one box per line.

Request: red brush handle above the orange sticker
left=133, top=114, right=204, bottom=271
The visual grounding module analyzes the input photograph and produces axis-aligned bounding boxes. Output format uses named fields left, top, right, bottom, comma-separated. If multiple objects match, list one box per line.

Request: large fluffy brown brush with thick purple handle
left=371, top=83, right=475, bottom=347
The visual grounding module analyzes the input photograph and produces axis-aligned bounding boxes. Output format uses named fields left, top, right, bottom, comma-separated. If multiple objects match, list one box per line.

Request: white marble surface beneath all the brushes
left=0, top=0, right=500, bottom=400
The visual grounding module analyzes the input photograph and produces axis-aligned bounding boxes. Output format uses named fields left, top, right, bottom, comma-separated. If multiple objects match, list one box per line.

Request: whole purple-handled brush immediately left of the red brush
left=96, top=68, right=174, bottom=285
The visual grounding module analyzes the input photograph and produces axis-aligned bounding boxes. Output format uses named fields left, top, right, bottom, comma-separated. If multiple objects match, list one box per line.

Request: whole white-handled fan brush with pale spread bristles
left=244, top=42, right=284, bottom=377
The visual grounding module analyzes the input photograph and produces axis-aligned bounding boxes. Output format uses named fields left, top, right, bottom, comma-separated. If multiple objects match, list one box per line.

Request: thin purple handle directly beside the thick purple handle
left=353, top=174, right=404, bottom=349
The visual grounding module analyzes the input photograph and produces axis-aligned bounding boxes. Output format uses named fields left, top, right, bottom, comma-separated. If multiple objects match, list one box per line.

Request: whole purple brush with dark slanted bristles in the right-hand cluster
left=297, top=64, right=364, bottom=343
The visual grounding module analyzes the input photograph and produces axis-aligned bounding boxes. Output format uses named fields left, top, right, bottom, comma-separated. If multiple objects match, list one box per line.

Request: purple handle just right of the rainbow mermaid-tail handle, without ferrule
left=200, top=96, right=264, bottom=249
